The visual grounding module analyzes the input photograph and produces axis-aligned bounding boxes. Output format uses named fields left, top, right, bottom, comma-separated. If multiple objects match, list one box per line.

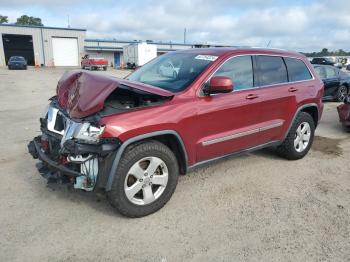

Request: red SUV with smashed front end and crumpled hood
left=28, top=48, right=323, bottom=217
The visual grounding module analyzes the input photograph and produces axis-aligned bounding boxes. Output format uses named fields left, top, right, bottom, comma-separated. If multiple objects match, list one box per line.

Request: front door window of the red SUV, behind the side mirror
left=214, top=56, right=254, bottom=90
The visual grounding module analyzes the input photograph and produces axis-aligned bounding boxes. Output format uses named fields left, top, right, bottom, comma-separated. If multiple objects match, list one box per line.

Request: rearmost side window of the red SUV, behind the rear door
left=284, top=57, right=312, bottom=82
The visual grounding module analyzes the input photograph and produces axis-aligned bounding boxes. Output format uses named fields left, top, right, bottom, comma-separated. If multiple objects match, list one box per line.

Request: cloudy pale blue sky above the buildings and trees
left=0, top=0, right=350, bottom=51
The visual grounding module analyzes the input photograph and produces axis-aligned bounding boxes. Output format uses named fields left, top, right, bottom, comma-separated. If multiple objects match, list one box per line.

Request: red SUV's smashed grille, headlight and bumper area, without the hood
left=28, top=100, right=120, bottom=191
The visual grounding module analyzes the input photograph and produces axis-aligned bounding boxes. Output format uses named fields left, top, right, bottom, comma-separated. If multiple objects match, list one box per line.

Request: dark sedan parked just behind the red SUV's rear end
left=314, top=65, right=350, bottom=102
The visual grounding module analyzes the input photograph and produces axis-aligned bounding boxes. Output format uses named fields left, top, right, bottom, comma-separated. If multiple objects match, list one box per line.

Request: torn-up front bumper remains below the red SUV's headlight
left=28, top=132, right=120, bottom=191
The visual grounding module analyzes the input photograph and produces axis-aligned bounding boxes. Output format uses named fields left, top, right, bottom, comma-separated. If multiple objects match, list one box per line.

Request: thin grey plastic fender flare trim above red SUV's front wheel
left=105, top=130, right=188, bottom=191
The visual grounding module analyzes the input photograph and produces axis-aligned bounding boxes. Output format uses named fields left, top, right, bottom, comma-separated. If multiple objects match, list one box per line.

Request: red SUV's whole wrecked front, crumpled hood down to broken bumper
left=28, top=71, right=173, bottom=191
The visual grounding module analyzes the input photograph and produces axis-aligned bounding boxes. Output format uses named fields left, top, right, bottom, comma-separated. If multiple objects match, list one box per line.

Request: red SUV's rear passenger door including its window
left=255, top=55, right=299, bottom=144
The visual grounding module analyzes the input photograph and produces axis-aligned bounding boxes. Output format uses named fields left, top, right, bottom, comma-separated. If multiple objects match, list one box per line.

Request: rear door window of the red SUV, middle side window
left=256, top=56, right=288, bottom=86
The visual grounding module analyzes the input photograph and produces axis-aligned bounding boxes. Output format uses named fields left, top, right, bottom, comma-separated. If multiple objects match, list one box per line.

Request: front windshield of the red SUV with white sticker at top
left=127, top=53, right=217, bottom=92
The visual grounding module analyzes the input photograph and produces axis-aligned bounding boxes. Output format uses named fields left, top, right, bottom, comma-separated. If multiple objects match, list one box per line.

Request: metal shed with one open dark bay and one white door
left=0, top=24, right=86, bottom=66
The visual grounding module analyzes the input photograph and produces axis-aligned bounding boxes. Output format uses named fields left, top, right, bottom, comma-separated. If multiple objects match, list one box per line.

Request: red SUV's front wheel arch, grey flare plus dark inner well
left=105, top=130, right=188, bottom=191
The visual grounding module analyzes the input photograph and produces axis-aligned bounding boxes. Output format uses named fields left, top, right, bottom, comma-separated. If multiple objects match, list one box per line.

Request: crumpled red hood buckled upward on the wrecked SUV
left=56, top=70, right=174, bottom=118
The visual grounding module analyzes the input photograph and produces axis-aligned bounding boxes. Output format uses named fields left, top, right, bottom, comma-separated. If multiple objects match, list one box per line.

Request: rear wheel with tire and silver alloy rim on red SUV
left=277, top=112, right=315, bottom=160
